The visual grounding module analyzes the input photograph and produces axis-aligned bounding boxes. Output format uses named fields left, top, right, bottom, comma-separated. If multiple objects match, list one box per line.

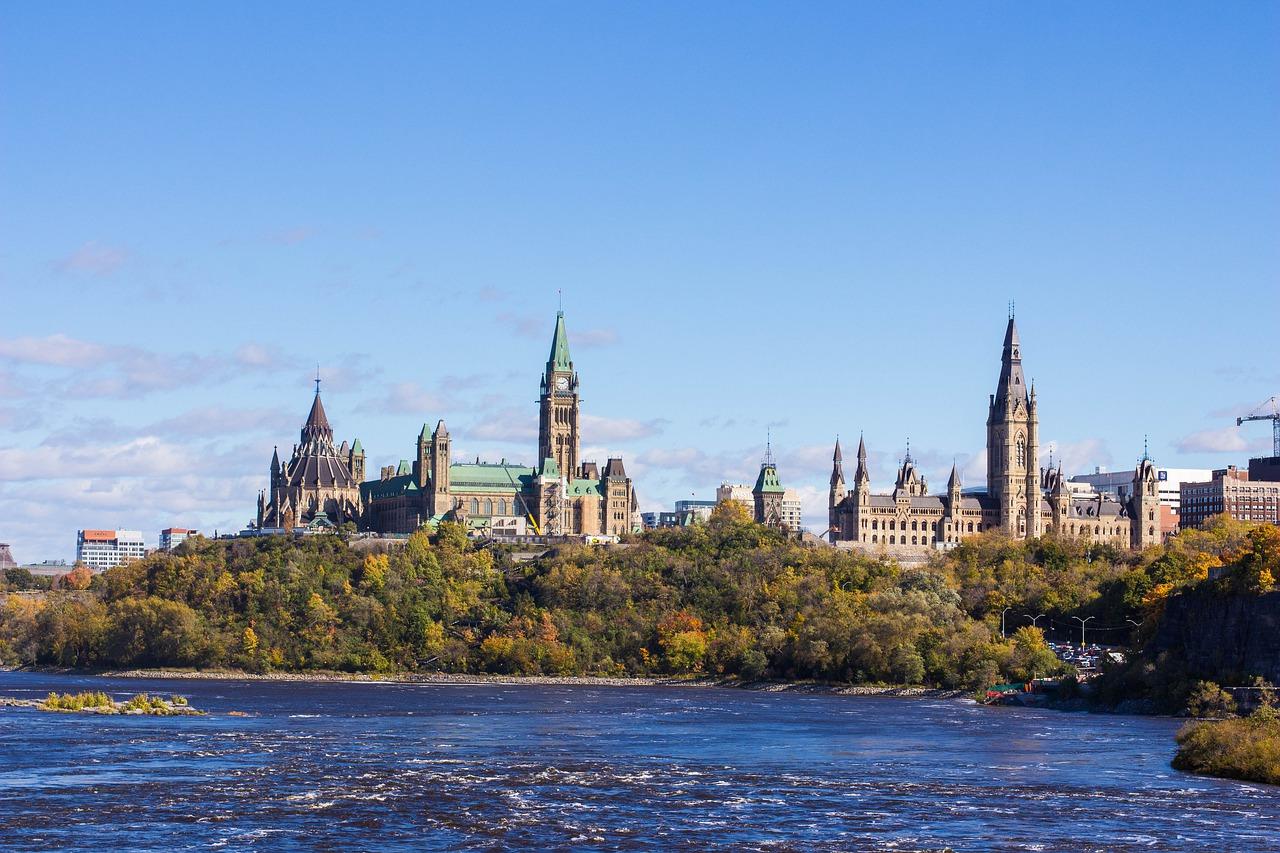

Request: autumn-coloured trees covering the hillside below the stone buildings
left=0, top=505, right=1274, bottom=688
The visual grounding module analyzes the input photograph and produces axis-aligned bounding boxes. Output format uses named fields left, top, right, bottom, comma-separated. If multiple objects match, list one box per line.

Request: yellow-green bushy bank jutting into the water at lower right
left=1172, top=707, right=1280, bottom=785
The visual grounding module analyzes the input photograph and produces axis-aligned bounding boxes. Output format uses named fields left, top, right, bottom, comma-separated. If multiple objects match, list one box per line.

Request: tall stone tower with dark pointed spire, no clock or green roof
left=987, top=313, right=1041, bottom=539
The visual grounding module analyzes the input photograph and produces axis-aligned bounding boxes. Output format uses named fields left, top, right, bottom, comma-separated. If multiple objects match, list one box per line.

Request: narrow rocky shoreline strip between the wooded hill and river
left=0, top=666, right=969, bottom=699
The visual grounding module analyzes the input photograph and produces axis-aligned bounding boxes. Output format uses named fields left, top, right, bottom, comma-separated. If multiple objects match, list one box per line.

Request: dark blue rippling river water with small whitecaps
left=0, top=672, right=1280, bottom=850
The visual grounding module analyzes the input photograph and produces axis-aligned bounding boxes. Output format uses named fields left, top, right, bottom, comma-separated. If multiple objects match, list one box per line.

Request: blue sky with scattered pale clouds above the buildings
left=0, top=3, right=1280, bottom=562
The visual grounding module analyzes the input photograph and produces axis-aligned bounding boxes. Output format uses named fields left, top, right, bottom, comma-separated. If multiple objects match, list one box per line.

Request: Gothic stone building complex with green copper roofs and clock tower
left=257, top=311, right=639, bottom=537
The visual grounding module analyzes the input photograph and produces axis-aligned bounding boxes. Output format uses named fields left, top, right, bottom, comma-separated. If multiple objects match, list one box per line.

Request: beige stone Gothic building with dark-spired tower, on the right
left=828, top=318, right=1161, bottom=553
